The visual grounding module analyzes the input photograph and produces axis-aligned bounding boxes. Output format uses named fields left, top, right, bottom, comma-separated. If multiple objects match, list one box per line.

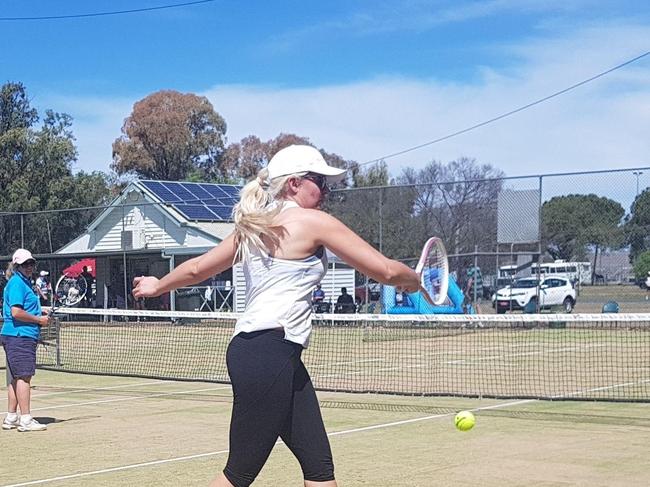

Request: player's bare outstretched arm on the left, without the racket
left=133, top=234, right=236, bottom=298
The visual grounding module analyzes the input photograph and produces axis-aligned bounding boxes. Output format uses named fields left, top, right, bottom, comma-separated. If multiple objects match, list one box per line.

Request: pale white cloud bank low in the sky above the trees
left=48, top=25, right=650, bottom=185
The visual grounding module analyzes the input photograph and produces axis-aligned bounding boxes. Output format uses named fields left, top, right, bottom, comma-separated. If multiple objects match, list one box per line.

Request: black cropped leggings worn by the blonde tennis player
left=223, top=329, right=334, bottom=487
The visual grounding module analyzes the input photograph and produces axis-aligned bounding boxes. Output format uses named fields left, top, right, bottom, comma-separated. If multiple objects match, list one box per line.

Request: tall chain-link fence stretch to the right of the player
left=328, top=168, right=650, bottom=312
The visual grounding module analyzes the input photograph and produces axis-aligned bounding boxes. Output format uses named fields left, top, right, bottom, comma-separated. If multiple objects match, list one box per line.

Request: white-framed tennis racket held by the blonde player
left=415, top=237, right=449, bottom=306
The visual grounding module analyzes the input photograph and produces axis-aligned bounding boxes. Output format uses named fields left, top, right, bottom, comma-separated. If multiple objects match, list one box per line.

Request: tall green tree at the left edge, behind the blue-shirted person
left=0, top=83, right=108, bottom=255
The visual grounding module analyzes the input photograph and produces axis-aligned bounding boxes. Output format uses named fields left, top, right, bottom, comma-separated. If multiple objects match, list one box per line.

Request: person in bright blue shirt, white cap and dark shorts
left=0, top=249, right=48, bottom=431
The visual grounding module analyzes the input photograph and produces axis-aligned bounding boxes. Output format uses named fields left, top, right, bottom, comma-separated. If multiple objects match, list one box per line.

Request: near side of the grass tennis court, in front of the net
left=0, top=371, right=650, bottom=487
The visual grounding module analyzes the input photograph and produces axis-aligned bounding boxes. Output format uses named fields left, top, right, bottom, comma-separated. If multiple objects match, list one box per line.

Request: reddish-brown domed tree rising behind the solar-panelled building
left=111, top=90, right=226, bottom=181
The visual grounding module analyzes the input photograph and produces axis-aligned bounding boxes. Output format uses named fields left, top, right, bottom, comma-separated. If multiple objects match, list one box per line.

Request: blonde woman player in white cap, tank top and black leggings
left=133, top=145, right=420, bottom=487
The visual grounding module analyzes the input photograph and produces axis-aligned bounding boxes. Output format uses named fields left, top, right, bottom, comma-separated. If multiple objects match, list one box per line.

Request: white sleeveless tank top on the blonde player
left=234, top=201, right=327, bottom=348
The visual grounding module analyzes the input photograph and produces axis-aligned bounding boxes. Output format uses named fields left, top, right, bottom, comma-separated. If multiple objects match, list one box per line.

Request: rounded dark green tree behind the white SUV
left=542, top=194, right=625, bottom=283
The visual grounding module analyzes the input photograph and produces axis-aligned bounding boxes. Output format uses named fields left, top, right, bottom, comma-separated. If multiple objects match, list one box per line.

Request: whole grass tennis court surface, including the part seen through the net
left=0, top=311, right=650, bottom=487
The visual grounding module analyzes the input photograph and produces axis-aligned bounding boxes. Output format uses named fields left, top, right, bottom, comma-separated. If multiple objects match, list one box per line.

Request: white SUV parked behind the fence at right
left=494, top=277, right=576, bottom=313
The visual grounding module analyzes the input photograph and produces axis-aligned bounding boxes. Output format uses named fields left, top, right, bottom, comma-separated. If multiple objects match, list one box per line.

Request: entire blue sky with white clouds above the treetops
left=0, top=0, right=650, bottom=179
